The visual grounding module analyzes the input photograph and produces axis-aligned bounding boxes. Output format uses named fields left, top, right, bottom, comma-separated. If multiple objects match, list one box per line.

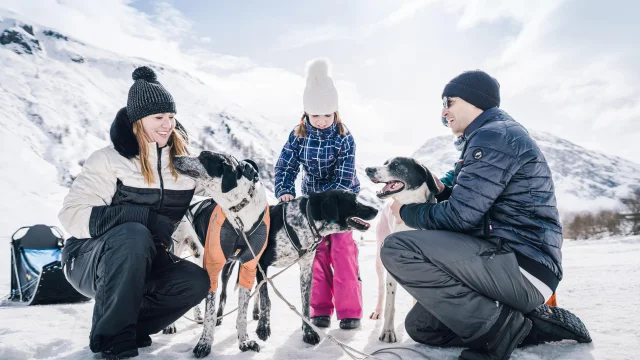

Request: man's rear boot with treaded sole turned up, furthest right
left=521, top=305, right=592, bottom=346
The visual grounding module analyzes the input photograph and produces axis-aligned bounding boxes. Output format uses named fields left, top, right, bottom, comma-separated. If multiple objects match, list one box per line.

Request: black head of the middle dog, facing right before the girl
left=309, top=190, right=378, bottom=233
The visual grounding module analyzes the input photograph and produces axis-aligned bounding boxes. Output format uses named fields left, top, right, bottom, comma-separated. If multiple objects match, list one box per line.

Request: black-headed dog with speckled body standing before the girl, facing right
left=218, top=190, right=378, bottom=345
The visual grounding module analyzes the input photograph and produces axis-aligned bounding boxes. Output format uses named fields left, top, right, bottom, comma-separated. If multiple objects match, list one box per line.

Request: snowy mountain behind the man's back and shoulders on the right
left=413, top=131, right=640, bottom=212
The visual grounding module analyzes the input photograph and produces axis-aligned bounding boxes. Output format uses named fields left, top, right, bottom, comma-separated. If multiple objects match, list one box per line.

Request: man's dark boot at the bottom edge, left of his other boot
left=458, top=309, right=532, bottom=360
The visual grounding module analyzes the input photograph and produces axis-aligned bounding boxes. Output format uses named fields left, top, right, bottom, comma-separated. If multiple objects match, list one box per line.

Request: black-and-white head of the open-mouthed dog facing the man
left=365, top=157, right=438, bottom=204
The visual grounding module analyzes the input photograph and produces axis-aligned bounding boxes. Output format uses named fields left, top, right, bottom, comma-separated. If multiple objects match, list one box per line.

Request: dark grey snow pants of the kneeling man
left=380, top=230, right=544, bottom=348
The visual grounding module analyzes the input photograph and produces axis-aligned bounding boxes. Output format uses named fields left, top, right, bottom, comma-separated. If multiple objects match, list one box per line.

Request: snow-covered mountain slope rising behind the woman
left=0, top=13, right=380, bottom=231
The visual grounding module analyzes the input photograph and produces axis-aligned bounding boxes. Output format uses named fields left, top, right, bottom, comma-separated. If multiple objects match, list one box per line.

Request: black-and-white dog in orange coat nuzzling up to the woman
left=173, top=151, right=267, bottom=358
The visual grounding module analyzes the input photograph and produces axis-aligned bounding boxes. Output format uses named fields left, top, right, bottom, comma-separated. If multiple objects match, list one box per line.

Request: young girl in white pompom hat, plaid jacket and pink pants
left=275, top=60, right=362, bottom=329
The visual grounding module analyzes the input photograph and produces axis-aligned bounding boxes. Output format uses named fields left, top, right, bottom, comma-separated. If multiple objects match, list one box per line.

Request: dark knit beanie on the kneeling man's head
left=442, top=70, right=500, bottom=110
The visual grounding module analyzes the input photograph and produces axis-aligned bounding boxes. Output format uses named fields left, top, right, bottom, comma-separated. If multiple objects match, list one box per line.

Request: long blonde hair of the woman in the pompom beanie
left=133, top=120, right=189, bottom=185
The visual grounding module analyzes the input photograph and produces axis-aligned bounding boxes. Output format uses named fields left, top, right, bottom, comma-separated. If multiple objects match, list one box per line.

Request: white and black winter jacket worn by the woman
left=58, top=109, right=201, bottom=239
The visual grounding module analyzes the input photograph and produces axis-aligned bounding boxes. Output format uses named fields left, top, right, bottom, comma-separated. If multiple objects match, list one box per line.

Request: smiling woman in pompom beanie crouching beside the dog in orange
left=59, top=66, right=209, bottom=359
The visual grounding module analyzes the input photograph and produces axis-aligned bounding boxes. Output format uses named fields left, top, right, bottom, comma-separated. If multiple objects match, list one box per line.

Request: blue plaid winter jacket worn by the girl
left=275, top=121, right=360, bottom=198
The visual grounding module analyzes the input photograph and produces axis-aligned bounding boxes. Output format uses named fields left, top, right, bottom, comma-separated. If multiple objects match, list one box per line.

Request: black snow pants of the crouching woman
left=62, top=222, right=209, bottom=352
